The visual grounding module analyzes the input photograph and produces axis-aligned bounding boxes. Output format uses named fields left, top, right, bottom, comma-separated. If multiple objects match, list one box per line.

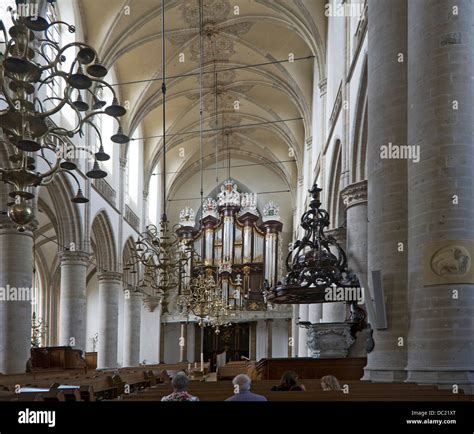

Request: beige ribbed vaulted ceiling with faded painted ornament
left=76, top=0, right=326, bottom=198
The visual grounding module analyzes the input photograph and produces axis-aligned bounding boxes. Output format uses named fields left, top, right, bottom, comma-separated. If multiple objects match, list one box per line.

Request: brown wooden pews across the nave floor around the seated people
left=0, top=362, right=474, bottom=401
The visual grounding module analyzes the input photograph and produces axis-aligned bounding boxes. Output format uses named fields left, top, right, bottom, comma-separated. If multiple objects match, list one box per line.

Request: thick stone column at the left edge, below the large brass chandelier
left=0, top=222, right=33, bottom=374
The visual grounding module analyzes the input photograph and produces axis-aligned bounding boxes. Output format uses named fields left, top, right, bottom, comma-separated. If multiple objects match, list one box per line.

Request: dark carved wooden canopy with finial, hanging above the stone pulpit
left=265, top=184, right=360, bottom=304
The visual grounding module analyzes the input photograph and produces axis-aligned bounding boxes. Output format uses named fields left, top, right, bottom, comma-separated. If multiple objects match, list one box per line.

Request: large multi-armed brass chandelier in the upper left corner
left=0, top=4, right=129, bottom=231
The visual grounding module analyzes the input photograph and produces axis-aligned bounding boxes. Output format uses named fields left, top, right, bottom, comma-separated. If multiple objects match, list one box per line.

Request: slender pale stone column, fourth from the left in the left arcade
left=122, top=289, right=142, bottom=367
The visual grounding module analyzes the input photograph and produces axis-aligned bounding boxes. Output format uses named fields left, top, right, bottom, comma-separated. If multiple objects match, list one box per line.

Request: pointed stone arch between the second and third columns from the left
left=91, top=210, right=118, bottom=273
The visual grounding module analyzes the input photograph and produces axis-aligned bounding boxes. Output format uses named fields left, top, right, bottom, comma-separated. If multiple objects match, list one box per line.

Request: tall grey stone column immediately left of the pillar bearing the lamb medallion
left=364, top=0, right=408, bottom=381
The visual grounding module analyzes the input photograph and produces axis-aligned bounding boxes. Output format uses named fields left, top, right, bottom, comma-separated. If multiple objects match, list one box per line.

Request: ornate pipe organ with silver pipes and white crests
left=176, top=179, right=283, bottom=311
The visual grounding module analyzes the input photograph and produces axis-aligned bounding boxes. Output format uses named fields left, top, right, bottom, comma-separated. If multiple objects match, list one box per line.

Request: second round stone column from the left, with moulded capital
left=59, top=250, right=89, bottom=351
